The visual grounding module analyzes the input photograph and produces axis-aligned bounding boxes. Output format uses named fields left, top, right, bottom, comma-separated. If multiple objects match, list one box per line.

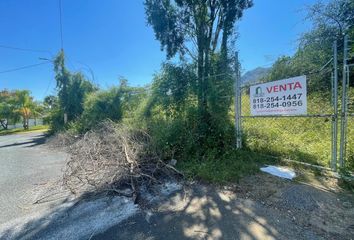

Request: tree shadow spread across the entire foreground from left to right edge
left=0, top=175, right=353, bottom=240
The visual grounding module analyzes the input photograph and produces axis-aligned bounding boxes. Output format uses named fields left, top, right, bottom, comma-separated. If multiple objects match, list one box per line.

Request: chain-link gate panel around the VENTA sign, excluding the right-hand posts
left=241, top=75, right=333, bottom=167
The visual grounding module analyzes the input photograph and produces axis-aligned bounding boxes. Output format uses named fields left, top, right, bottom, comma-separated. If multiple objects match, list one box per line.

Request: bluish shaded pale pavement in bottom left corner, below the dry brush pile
left=0, top=191, right=137, bottom=240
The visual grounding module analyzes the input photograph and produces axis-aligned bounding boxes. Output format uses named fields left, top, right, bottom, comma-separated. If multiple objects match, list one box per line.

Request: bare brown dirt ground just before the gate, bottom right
left=234, top=171, right=354, bottom=239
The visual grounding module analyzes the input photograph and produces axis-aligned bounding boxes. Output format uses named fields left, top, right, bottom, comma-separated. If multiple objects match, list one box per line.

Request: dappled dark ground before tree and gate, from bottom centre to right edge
left=93, top=171, right=354, bottom=240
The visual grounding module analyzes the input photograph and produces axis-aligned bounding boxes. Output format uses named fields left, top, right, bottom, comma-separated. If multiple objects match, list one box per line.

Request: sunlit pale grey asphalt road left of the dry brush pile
left=0, top=132, right=66, bottom=224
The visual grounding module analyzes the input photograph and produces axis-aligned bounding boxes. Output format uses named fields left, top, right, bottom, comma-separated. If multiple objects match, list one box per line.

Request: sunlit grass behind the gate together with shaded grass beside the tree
left=177, top=89, right=354, bottom=184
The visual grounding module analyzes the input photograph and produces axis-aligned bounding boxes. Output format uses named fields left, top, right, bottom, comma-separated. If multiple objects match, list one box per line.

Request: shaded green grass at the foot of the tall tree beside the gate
left=177, top=150, right=277, bottom=184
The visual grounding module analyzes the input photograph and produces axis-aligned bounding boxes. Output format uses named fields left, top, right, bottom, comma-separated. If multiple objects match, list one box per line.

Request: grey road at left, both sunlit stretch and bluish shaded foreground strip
left=0, top=132, right=138, bottom=240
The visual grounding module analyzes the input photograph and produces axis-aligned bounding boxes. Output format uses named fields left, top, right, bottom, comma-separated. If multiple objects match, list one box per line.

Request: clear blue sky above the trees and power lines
left=0, top=0, right=315, bottom=100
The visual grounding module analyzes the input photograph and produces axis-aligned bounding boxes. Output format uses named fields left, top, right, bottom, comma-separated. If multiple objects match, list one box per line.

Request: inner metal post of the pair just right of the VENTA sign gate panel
left=331, top=40, right=338, bottom=171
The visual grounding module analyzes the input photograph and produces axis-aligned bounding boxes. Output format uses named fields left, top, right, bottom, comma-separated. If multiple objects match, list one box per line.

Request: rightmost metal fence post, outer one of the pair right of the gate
left=339, top=35, right=348, bottom=168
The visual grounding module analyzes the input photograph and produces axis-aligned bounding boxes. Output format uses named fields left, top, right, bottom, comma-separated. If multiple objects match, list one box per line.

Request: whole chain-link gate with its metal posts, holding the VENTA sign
left=235, top=36, right=354, bottom=171
